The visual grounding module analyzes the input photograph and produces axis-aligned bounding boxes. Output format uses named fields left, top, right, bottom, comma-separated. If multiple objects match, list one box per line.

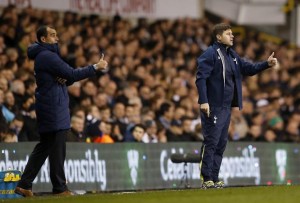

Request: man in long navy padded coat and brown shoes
left=15, top=26, right=107, bottom=197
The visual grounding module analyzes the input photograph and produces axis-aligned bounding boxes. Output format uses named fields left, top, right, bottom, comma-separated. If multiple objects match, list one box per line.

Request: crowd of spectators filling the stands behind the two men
left=0, top=6, right=300, bottom=143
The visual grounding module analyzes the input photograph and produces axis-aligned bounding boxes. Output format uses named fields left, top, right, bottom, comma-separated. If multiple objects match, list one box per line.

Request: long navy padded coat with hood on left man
left=27, top=42, right=96, bottom=133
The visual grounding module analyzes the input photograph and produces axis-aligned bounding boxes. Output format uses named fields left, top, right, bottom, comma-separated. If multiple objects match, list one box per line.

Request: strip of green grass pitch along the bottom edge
left=0, top=185, right=300, bottom=203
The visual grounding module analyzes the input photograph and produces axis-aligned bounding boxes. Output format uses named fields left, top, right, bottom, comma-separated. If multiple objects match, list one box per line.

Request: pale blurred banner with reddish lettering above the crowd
left=0, top=0, right=204, bottom=19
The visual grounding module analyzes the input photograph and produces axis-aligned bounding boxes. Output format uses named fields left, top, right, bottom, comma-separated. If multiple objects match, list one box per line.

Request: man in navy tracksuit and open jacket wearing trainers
left=196, top=23, right=277, bottom=189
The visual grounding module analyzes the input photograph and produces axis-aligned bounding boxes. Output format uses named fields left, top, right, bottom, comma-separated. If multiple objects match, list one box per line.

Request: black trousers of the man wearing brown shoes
left=18, top=130, right=68, bottom=193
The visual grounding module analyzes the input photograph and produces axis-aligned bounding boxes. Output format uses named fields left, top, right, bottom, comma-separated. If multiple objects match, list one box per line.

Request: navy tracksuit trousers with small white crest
left=200, top=107, right=231, bottom=182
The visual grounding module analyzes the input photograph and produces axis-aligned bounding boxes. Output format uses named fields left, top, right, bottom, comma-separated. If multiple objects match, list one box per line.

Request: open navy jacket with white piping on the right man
left=196, top=42, right=269, bottom=109
